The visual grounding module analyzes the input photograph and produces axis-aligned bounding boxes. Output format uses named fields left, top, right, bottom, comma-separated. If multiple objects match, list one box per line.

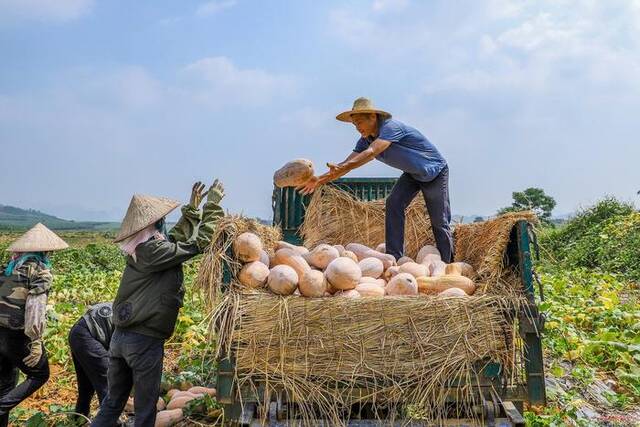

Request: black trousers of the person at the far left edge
left=0, top=328, right=49, bottom=427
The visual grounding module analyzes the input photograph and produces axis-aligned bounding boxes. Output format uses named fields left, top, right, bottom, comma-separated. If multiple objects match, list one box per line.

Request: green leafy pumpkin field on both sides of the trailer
left=0, top=199, right=640, bottom=426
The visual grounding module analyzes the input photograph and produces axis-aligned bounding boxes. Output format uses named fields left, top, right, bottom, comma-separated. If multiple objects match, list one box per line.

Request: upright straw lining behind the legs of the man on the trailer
left=300, top=185, right=435, bottom=258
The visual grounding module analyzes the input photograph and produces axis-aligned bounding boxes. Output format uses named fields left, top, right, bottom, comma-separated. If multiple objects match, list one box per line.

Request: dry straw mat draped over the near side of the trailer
left=215, top=291, right=514, bottom=425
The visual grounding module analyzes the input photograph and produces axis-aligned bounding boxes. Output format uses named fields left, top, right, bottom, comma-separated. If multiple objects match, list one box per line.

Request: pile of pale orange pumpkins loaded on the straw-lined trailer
left=233, top=232, right=476, bottom=298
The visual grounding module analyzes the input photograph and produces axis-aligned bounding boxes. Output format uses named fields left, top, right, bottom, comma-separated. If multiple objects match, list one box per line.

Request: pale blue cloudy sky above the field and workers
left=0, top=0, right=640, bottom=220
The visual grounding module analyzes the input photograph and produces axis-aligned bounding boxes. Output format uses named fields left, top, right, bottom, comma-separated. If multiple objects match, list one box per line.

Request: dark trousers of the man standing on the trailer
left=385, top=166, right=453, bottom=263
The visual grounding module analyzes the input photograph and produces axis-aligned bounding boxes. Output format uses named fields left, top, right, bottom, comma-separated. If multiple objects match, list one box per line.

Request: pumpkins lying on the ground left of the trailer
left=125, top=386, right=216, bottom=427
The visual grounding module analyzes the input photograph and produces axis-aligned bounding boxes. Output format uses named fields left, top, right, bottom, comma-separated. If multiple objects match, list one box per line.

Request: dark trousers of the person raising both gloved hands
left=91, top=329, right=164, bottom=427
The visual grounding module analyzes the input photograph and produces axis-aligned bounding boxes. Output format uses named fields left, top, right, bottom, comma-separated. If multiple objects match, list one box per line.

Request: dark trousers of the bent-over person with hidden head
left=69, top=319, right=109, bottom=417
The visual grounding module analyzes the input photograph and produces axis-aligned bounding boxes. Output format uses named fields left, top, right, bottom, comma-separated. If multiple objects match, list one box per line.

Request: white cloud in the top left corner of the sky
left=0, top=0, right=94, bottom=24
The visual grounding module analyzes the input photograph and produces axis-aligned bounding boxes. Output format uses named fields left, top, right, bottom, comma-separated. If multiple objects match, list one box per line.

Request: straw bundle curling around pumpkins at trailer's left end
left=196, top=215, right=282, bottom=306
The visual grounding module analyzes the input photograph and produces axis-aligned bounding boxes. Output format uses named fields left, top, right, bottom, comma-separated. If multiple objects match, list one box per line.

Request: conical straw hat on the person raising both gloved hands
left=114, top=194, right=180, bottom=242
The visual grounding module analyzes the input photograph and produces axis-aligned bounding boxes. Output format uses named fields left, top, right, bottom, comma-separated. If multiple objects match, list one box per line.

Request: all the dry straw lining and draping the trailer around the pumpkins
left=199, top=187, right=534, bottom=425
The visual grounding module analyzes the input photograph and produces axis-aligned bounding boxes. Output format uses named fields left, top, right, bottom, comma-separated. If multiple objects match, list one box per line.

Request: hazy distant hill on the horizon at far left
left=0, top=205, right=119, bottom=230
